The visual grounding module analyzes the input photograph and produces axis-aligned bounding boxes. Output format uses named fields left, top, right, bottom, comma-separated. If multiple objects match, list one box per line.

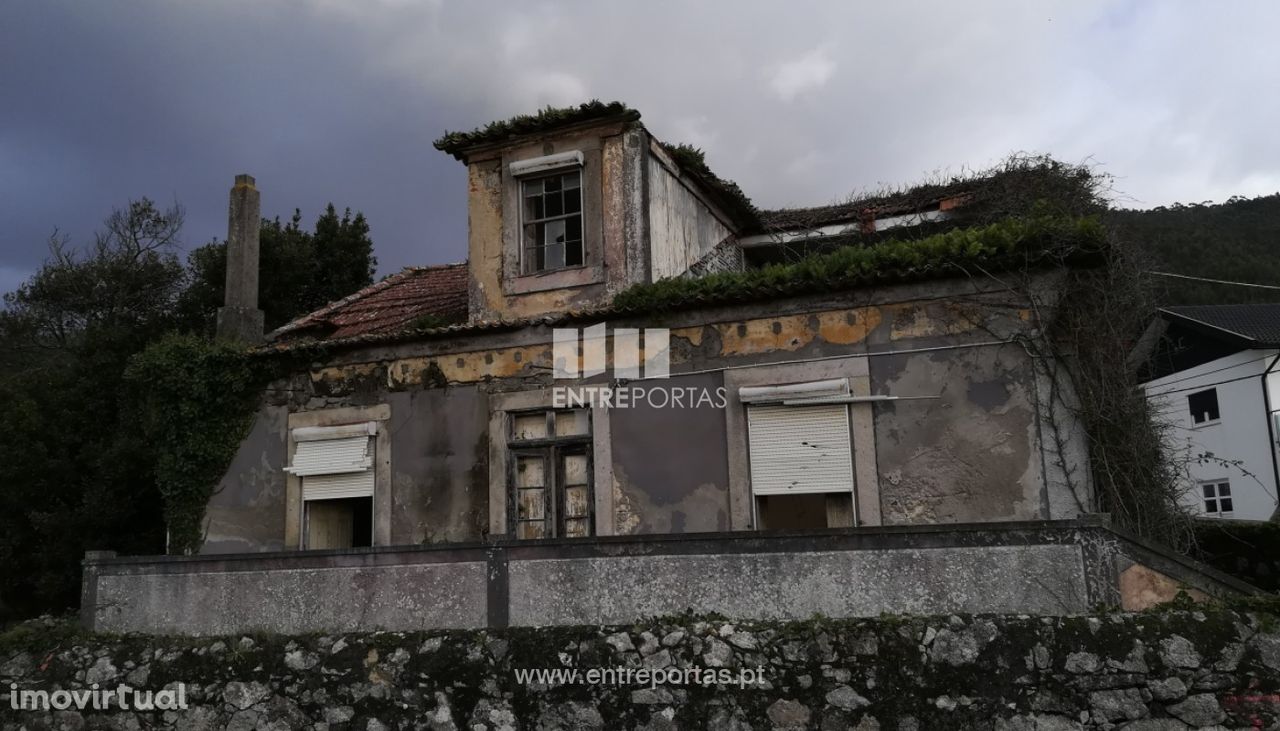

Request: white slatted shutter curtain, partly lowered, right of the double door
left=746, top=405, right=854, bottom=495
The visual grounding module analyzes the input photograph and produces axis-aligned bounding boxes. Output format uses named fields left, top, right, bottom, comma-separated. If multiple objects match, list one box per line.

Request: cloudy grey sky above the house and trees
left=0, top=0, right=1280, bottom=297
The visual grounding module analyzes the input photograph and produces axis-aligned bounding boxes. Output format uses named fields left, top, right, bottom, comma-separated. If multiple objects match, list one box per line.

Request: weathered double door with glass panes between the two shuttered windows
left=509, top=408, right=594, bottom=539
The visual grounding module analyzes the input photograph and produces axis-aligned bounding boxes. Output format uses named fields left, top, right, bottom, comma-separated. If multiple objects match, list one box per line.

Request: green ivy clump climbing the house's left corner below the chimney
left=125, top=334, right=266, bottom=554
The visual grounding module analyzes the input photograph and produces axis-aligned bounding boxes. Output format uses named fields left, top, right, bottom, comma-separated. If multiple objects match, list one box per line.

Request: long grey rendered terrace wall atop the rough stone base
left=81, top=520, right=1251, bottom=635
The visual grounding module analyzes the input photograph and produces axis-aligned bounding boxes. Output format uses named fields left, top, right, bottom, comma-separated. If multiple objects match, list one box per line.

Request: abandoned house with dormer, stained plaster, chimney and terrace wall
left=86, top=102, right=1259, bottom=631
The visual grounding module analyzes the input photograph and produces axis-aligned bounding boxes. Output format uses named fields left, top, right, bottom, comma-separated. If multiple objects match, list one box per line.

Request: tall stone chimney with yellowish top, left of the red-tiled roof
left=218, top=175, right=262, bottom=344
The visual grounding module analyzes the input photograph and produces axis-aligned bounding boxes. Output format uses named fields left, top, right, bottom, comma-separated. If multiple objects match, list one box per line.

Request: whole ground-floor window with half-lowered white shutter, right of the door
left=739, top=379, right=854, bottom=530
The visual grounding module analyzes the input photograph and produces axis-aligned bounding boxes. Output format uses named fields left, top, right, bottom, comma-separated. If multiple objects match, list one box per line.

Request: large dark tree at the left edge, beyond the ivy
left=0, top=198, right=186, bottom=615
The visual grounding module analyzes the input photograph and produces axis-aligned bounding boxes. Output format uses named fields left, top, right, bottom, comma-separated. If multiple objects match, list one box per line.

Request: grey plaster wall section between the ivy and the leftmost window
left=204, top=406, right=288, bottom=553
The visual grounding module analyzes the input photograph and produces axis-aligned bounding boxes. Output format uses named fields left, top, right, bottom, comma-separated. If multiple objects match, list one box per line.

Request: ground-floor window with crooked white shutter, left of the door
left=287, top=421, right=378, bottom=549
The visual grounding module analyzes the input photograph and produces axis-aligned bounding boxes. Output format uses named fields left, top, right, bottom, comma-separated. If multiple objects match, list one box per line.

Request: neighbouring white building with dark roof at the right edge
left=1144, top=303, right=1280, bottom=520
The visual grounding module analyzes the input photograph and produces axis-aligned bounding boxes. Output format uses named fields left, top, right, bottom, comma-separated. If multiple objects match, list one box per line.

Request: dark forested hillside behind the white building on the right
left=1111, top=193, right=1280, bottom=305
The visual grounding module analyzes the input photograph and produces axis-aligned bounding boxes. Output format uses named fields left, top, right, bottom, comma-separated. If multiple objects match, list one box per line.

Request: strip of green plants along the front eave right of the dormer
left=612, top=215, right=1108, bottom=312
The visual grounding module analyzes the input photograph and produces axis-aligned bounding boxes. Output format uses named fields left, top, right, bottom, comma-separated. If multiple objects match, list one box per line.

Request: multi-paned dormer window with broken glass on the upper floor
left=520, top=170, right=584, bottom=274
